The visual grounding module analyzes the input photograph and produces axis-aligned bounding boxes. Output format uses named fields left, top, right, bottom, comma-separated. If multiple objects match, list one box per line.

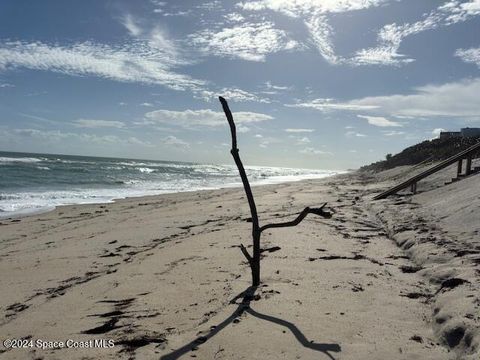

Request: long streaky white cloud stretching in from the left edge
left=0, top=41, right=205, bottom=91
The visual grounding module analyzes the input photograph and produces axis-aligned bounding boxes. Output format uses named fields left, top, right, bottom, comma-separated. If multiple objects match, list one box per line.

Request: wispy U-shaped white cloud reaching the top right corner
left=237, top=0, right=480, bottom=66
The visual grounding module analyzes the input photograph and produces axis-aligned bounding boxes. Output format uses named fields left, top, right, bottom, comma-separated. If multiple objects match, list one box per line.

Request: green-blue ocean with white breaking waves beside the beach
left=0, top=152, right=339, bottom=218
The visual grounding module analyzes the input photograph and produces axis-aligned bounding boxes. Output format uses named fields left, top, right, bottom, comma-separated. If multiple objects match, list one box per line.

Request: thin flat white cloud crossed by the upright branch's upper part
left=144, top=109, right=273, bottom=129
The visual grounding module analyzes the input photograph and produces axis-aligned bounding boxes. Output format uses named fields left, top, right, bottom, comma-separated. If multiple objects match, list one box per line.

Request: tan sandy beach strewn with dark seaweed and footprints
left=0, top=169, right=480, bottom=360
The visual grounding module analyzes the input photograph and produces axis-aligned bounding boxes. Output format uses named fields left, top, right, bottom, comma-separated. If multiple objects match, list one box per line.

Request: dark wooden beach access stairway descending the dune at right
left=373, top=142, right=480, bottom=200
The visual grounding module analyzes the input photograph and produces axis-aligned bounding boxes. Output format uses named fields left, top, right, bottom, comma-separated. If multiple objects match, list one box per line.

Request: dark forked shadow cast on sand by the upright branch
left=160, top=286, right=341, bottom=360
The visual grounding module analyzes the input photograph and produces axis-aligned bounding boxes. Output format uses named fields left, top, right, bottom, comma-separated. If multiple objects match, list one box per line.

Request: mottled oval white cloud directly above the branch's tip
left=189, top=22, right=298, bottom=61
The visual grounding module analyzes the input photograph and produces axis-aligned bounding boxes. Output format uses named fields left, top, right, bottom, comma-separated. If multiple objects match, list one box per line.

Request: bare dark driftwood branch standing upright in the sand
left=219, top=96, right=332, bottom=287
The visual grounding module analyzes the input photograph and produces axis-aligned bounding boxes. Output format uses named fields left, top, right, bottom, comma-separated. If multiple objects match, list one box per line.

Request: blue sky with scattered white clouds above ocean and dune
left=0, top=0, right=480, bottom=169
